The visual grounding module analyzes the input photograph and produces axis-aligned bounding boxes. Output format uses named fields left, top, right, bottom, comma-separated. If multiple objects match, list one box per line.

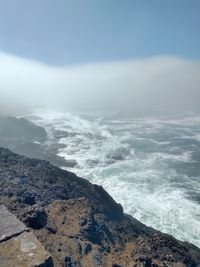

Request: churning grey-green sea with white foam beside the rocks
left=28, top=109, right=200, bottom=247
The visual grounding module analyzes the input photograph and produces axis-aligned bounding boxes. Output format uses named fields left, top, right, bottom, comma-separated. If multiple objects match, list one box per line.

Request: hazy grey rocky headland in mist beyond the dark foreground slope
left=0, top=116, right=74, bottom=167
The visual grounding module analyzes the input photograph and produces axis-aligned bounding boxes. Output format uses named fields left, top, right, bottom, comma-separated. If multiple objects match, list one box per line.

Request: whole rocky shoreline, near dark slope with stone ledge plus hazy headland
left=0, top=116, right=200, bottom=267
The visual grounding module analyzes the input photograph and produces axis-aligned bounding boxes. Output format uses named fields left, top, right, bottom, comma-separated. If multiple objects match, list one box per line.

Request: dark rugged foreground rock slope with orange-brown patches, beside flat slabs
left=0, top=148, right=200, bottom=267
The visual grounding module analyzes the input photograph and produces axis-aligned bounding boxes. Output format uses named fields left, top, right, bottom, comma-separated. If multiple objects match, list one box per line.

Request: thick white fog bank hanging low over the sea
left=0, top=53, right=200, bottom=115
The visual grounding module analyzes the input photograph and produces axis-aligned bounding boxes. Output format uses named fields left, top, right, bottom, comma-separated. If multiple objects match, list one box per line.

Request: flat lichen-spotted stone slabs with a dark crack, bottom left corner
left=0, top=205, right=53, bottom=267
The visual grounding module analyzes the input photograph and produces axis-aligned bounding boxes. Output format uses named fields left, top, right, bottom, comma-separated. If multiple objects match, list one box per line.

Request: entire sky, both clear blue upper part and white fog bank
left=0, top=0, right=200, bottom=115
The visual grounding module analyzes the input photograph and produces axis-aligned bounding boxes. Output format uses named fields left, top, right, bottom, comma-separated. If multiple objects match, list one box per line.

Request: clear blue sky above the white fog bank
left=0, top=0, right=200, bottom=65
